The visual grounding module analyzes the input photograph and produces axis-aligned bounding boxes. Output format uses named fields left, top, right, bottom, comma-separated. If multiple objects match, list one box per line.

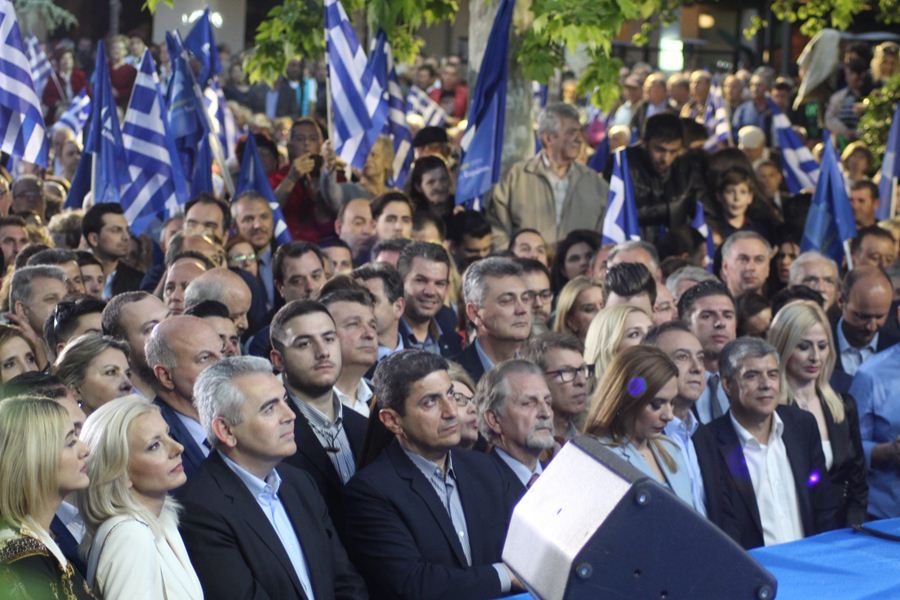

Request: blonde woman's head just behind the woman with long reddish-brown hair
left=584, top=304, right=653, bottom=381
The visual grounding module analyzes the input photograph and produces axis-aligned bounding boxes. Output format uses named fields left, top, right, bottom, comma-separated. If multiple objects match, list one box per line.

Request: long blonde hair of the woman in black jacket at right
left=769, top=300, right=844, bottom=423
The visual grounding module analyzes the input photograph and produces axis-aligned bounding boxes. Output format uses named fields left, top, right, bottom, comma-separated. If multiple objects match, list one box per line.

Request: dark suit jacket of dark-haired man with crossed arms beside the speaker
left=344, top=440, right=514, bottom=600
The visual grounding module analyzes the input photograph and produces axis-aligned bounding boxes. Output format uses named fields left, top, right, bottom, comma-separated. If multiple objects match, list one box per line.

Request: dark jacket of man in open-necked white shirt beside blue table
left=693, top=406, right=839, bottom=549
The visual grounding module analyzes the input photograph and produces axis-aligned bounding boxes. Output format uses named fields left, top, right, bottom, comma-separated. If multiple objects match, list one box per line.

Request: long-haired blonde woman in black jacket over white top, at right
left=769, top=301, right=869, bottom=526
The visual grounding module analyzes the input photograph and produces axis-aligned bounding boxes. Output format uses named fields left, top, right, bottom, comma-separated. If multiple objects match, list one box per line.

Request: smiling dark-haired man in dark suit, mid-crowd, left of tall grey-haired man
left=397, top=242, right=462, bottom=358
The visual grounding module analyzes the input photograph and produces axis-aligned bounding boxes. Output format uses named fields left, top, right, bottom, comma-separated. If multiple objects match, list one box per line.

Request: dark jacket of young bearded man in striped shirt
left=284, top=402, right=367, bottom=532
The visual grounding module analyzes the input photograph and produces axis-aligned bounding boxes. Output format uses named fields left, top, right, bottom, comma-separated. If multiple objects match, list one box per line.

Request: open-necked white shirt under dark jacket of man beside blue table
left=728, top=412, right=803, bottom=546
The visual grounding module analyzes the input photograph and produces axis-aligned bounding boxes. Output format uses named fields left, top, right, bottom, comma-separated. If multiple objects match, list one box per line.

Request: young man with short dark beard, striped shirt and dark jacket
left=271, top=300, right=366, bottom=529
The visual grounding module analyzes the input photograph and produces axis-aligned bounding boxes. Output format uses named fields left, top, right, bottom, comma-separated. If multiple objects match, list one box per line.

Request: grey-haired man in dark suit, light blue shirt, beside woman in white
left=178, top=356, right=367, bottom=600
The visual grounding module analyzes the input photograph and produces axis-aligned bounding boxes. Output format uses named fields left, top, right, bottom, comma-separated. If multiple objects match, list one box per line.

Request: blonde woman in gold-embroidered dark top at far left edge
left=0, top=396, right=94, bottom=600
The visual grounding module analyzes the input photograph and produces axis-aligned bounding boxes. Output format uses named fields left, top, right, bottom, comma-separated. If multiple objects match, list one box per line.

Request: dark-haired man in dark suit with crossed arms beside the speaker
left=344, top=349, right=520, bottom=600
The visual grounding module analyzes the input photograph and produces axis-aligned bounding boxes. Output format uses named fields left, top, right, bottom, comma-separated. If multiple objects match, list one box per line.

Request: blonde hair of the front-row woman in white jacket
left=78, top=394, right=177, bottom=548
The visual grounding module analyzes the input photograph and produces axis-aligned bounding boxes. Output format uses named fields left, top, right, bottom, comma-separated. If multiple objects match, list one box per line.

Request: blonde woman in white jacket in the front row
left=78, top=395, right=203, bottom=600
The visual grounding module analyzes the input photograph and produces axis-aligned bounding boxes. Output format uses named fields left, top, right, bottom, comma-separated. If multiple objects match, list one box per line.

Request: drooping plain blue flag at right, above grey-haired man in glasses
left=800, top=131, right=856, bottom=264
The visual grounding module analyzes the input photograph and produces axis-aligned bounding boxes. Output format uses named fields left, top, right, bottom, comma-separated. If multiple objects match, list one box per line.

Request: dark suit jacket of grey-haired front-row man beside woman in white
left=178, top=451, right=368, bottom=600
